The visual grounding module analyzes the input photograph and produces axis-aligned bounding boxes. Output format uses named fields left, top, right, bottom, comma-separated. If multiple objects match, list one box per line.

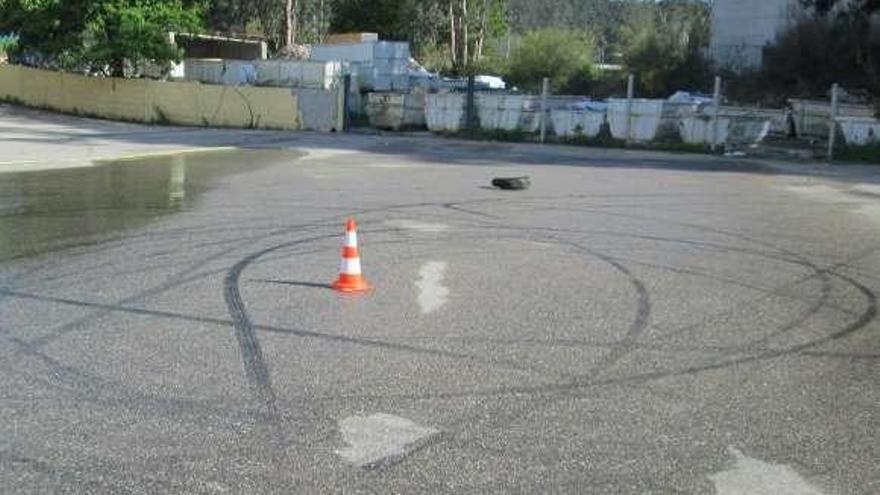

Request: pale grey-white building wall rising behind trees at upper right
left=709, top=0, right=801, bottom=70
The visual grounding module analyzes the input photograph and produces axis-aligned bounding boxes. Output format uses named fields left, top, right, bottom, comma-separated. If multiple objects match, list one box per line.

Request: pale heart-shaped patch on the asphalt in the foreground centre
left=336, top=413, right=440, bottom=468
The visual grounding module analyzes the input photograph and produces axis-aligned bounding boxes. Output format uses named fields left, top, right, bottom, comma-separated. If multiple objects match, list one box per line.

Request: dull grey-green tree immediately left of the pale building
left=621, top=0, right=711, bottom=97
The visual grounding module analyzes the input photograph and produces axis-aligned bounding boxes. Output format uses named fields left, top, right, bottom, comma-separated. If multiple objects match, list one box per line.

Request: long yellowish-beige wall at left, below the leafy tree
left=0, top=65, right=301, bottom=130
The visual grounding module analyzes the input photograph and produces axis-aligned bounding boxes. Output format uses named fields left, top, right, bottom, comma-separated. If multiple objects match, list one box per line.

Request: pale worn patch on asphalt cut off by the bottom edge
left=709, top=447, right=823, bottom=495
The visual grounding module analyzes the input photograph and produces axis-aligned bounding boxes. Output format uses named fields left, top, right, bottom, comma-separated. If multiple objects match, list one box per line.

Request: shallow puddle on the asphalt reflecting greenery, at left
left=0, top=149, right=302, bottom=261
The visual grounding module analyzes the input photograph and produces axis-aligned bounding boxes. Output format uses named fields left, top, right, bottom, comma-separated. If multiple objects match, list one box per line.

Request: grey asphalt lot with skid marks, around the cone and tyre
left=0, top=107, right=880, bottom=495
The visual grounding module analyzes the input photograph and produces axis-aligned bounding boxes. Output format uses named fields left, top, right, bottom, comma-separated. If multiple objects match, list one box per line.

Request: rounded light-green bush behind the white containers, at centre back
left=507, top=28, right=593, bottom=92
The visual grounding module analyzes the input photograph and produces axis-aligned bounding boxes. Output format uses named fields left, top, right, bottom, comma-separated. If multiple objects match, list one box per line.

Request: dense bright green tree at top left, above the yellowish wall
left=0, top=0, right=202, bottom=76
